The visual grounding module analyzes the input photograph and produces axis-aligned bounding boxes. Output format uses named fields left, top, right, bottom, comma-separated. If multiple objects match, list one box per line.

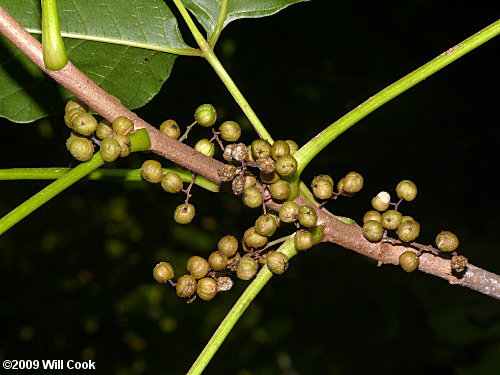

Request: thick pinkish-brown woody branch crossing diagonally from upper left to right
left=0, top=7, right=500, bottom=299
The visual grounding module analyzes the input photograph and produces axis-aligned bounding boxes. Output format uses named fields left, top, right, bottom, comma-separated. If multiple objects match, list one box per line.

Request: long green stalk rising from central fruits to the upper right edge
left=294, top=21, right=500, bottom=175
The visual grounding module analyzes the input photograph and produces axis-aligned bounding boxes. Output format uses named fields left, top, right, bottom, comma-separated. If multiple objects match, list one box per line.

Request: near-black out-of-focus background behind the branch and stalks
left=0, top=0, right=500, bottom=375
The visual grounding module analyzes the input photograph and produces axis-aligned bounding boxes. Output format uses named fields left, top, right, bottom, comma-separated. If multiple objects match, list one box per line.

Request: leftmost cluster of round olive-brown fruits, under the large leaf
left=64, top=100, right=139, bottom=162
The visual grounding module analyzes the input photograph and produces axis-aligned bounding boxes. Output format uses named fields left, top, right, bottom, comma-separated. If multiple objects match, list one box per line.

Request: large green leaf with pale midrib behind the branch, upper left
left=0, top=0, right=193, bottom=122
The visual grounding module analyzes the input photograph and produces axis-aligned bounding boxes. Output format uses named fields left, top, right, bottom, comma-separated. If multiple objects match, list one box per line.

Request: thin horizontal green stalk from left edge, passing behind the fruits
left=0, top=168, right=219, bottom=193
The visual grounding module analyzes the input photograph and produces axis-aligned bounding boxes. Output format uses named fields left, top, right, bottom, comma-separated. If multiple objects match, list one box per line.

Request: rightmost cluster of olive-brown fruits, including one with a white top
left=363, top=180, right=467, bottom=273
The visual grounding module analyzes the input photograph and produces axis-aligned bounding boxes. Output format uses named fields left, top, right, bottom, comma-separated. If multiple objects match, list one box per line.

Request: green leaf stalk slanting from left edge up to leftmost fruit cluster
left=0, top=152, right=103, bottom=234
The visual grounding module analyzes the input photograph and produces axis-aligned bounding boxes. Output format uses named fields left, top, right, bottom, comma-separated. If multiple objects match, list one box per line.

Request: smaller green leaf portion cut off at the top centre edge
left=183, top=0, right=309, bottom=37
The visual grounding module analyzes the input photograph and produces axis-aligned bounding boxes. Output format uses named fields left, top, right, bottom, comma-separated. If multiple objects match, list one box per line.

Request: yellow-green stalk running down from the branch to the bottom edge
left=187, top=236, right=297, bottom=375
